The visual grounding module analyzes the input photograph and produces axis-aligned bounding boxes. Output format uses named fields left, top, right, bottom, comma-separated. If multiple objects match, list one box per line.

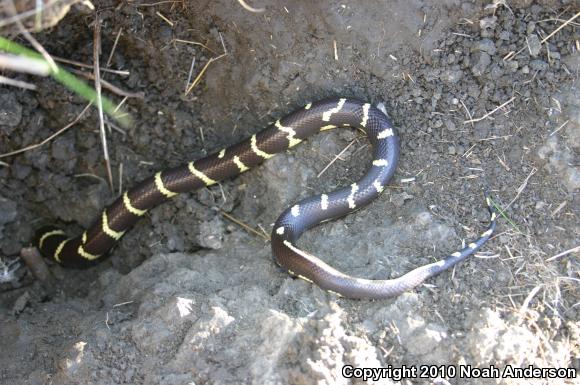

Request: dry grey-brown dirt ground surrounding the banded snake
left=0, top=0, right=580, bottom=385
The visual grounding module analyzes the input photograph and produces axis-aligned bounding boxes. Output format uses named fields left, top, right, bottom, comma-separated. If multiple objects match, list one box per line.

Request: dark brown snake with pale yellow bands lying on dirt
left=36, top=98, right=496, bottom=299
